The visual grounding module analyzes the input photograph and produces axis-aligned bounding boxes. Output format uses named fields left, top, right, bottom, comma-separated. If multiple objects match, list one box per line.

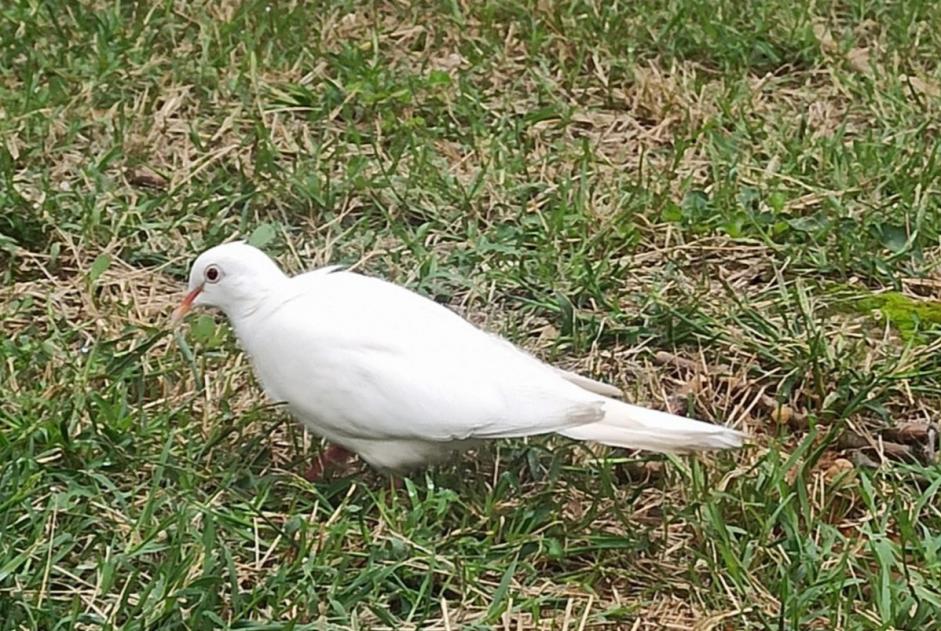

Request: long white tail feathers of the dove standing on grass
left=559, top=400, right=745, bottom=454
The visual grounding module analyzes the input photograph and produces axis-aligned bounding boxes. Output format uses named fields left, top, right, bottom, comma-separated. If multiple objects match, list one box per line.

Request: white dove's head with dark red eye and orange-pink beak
left=171, top=241, right=287, bottom=324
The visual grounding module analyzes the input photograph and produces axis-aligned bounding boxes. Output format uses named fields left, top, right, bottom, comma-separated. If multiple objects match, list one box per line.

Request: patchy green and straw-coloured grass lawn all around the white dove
left=0, top=0, right=941, bottom=630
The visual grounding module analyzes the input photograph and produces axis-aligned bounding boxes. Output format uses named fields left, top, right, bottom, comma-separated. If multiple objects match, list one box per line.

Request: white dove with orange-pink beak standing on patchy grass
left=173, top=242, right=744, bottom=475
